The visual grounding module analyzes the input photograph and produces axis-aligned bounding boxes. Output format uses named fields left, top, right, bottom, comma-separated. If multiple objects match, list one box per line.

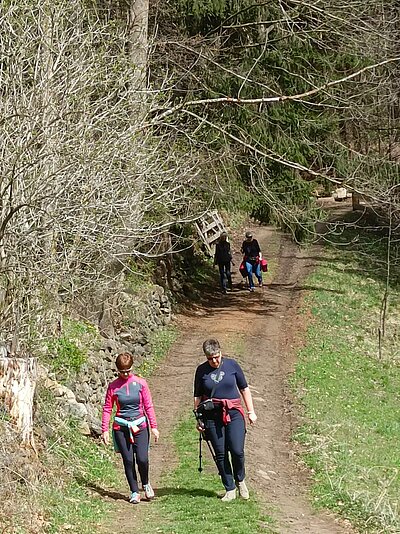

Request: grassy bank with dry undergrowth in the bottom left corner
left=0, top=388, right=119, bottom=534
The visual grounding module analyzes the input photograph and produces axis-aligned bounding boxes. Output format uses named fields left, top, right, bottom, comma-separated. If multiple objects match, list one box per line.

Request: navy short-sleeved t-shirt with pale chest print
left=194, top=358, right=247, bottom=399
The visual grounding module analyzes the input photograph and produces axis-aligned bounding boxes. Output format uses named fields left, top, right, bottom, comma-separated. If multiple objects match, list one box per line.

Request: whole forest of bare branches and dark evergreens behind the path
left=0, top=0, right=399, bottom=354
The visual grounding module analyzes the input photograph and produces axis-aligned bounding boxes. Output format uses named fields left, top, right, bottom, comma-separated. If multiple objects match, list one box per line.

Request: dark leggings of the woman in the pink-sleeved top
left=113, top=426, right=149, bottom=491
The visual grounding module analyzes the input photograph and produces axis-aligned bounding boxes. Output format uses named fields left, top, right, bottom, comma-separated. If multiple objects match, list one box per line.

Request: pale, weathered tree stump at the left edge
left=0, top=356, right=37, bottom=448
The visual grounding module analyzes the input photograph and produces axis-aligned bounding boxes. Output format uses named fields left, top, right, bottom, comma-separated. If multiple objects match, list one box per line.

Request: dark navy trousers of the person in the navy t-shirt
left=205, top=410, right=246, bottom=491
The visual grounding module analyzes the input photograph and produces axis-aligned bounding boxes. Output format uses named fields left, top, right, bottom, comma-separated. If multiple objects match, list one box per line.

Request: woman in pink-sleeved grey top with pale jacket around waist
left=101, top=352, right=159, bottom=504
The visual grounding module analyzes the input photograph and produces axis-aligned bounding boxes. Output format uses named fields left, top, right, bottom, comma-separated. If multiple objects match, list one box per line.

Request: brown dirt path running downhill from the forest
left=99, top=227, right=350, bottom=534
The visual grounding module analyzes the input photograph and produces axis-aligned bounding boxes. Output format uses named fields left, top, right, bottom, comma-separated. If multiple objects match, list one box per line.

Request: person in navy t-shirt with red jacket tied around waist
left=194, top=339, right=257, bottom=501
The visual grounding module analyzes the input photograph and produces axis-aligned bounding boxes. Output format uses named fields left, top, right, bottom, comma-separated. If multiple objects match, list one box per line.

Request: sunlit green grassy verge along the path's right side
left=293, top=227, right=400, bottom=533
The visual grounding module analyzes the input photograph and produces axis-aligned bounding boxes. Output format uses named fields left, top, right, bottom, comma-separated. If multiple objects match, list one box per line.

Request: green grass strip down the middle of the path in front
left=140, top=417, right=272, bottom=534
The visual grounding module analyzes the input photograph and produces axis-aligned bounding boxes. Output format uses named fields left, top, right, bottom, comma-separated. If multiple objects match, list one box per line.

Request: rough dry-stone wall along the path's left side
left=43, top=285, right=172, bottom=434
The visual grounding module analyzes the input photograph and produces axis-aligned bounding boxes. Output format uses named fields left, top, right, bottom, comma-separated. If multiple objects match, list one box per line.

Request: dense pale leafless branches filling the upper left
left=0, top=0, right=217, bottom=344
